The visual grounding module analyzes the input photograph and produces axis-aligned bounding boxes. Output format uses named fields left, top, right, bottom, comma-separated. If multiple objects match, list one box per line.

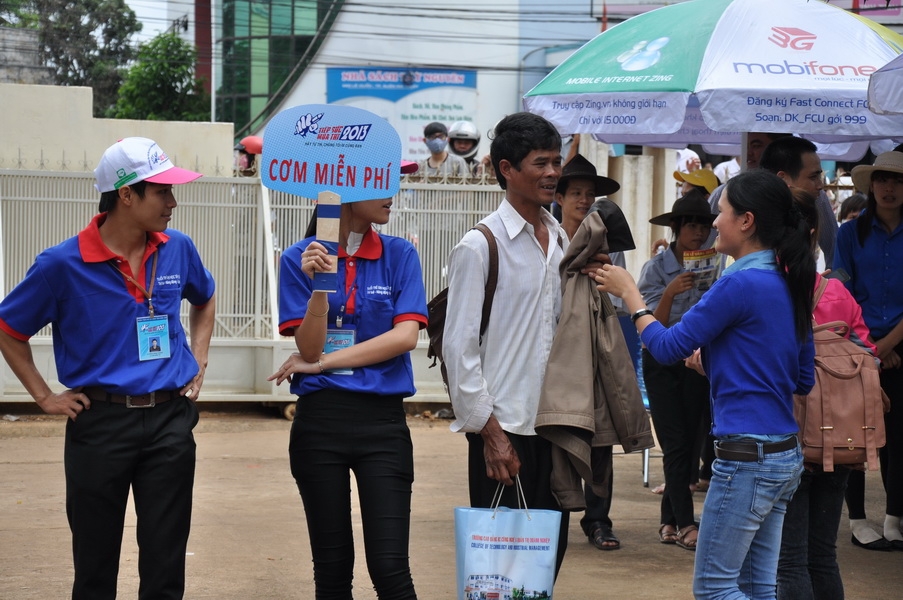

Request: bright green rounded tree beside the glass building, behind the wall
left=110, top=33, right=210, bottom=121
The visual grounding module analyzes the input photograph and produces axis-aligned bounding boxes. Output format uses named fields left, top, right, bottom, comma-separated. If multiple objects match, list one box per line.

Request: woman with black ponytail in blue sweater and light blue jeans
left=595, top=171, right=815, bottom=599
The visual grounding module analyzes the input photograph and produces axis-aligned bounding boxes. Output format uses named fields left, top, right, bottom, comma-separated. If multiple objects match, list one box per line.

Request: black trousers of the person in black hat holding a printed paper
left=643, top=349, right=711, bottom=528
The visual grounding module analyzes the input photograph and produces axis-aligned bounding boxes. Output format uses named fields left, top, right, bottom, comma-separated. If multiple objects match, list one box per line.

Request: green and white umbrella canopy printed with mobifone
left=524, top=0, right=903, bottom=144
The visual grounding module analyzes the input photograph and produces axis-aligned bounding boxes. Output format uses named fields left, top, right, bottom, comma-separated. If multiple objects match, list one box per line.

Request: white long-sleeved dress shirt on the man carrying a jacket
left=443, top=200, right=567, bottom=435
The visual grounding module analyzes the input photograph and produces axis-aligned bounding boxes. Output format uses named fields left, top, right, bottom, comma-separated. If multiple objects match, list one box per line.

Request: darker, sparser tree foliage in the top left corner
left=0, top=0, right=141, bottom=116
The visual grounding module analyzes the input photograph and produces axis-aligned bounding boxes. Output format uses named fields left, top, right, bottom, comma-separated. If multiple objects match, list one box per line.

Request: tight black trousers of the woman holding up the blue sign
left=289, top=390, right=417, bottom=600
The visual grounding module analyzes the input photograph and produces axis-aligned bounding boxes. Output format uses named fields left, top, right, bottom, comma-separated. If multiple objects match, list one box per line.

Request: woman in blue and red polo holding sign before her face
left=271, top=165, right=427, bottom=600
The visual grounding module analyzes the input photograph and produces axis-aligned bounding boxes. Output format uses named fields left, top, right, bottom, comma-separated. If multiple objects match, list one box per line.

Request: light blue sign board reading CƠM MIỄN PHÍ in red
left=260, top=104, right=401, bottom=202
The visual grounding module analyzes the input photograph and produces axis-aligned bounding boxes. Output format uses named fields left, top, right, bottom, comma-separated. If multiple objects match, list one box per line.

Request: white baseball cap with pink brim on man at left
left=94, top=137, right=201, bottom=193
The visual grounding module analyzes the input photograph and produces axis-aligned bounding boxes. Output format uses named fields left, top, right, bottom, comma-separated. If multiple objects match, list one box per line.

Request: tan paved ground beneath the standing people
left=0, top=404, right=903, bottom=600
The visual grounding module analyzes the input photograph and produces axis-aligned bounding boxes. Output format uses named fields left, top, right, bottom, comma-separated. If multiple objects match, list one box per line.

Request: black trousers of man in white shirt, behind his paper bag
left=467, top=431, right=570, bottom=578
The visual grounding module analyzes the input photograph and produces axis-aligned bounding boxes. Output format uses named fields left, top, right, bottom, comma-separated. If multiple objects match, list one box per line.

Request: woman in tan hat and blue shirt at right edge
left=834, top=152, right=903, bottom=550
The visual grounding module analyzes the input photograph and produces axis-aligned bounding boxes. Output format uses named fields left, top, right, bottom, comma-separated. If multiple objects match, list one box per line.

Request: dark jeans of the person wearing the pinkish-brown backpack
left=778, top=465, right=850, bottom=600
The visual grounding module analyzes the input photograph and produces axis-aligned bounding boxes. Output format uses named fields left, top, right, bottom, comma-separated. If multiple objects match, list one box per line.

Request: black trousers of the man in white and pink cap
left=64, top=398, right=198, bottom=600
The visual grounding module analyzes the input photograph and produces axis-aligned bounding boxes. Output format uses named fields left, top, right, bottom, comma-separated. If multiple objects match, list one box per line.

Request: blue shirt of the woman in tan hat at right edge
left=834, top=217, right=903, bottom=340
